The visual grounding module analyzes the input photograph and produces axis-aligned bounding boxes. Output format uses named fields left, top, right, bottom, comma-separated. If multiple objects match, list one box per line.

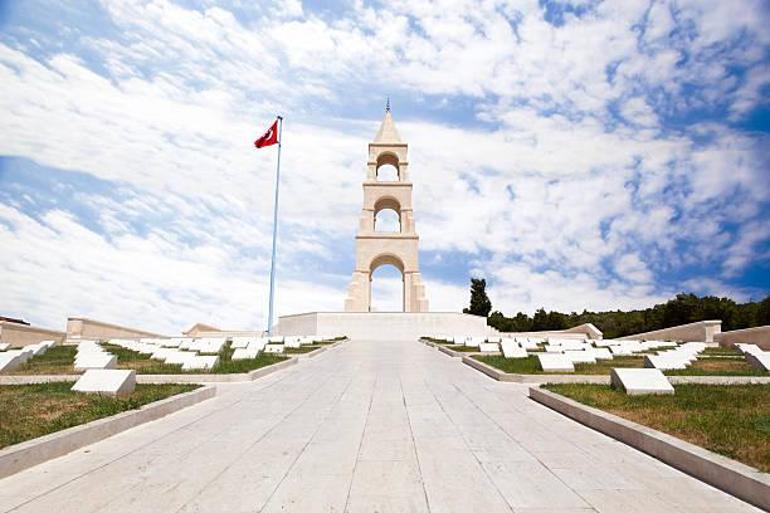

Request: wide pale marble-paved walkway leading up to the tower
left=0, top=341, right=759, bottom=513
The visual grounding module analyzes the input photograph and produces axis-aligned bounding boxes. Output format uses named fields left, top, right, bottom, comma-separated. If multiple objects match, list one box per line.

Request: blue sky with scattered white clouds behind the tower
left=0, top=0, right=770, bottom=334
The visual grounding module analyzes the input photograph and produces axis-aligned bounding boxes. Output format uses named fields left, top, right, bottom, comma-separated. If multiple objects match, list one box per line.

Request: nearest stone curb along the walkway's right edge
left=529, top=387, right=770, bottom=511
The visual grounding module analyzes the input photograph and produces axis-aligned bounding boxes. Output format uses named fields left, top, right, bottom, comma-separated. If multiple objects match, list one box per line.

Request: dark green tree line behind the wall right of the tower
left=463, top=278, right=770, bottom=338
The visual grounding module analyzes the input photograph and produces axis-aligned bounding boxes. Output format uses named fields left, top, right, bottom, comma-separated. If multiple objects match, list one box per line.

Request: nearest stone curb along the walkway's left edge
left=0, top=386, right=216, bottom=478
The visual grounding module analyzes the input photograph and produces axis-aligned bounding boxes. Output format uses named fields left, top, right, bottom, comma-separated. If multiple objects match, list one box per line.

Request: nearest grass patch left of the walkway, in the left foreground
left=0, top=383, right=198, bottom=448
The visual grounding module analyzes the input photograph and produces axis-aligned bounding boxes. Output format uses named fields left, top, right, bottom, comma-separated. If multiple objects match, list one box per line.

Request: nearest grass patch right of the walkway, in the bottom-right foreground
left=544, top=384, right=770, bottom=472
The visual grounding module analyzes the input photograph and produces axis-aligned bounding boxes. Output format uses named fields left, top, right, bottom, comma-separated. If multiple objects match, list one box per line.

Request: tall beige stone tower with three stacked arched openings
left=345, top=103, right=428, bottom=312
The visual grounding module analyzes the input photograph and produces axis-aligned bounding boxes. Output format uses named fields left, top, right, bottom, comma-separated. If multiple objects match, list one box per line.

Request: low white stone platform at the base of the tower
left=275, top=312, right=492, bottom=340
